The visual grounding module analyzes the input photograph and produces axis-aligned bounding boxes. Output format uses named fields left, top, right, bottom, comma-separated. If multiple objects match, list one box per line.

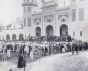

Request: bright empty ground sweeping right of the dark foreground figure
left=30, top=51, right=88, bottom=71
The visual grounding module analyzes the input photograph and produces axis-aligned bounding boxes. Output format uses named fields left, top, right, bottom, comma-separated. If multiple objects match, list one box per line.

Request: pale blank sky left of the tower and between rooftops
left=0, top=0, right=69, bottom=25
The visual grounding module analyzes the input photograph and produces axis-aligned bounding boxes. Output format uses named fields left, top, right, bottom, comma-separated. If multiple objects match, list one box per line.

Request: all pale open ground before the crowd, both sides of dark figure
left=0, top=51, right=88, bottom=71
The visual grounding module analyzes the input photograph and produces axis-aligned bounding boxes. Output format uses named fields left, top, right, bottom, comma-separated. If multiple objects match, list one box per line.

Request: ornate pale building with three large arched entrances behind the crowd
left=0, top=0, right=88, bottom=41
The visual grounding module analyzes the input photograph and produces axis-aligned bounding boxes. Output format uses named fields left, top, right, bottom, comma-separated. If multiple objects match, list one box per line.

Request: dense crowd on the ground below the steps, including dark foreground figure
left=0, top=41, right=88, bottom=68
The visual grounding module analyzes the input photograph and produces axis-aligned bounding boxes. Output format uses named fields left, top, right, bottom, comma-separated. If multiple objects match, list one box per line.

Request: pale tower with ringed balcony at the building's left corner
left=22, top=0, right=38, bottom=27
